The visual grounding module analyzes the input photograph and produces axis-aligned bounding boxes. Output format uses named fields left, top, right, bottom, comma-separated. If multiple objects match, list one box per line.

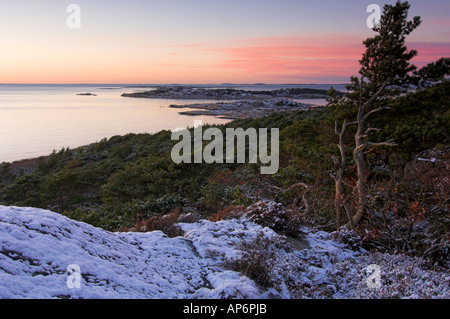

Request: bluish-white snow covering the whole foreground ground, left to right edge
left=0, top=206, right=450, bottom=299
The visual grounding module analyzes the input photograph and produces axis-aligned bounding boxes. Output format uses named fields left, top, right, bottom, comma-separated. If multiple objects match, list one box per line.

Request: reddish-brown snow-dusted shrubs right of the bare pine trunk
left=357, top=150, right=450, bottom=264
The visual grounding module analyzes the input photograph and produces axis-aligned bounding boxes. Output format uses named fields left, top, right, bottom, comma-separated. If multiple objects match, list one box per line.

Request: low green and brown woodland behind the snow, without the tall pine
left=0, top=81, right=450, bottom=262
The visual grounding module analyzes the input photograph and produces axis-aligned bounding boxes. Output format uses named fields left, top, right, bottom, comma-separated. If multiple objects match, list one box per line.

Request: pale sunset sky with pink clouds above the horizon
left=0, top=0, right=450, bottom=84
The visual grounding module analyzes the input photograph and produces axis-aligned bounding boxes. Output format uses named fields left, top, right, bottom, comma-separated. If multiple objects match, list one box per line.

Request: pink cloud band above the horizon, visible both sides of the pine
left=145, top=34, right=450, bottom=83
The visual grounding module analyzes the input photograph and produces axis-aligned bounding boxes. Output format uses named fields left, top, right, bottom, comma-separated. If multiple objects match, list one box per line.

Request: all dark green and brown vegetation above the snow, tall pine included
left=0, top=1, right=450, bottom=264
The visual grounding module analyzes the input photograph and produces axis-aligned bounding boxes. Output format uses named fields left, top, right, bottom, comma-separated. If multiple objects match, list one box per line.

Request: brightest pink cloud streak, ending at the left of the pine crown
left=204, top=35, right=364, bottom=79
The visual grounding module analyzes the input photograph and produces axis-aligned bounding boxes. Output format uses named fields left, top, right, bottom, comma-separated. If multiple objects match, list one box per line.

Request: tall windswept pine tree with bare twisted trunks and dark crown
left=332, top=1, right=421, bottom=228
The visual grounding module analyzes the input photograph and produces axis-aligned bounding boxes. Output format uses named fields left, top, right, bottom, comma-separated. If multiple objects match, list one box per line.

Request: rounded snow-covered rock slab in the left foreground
left=0, top=206, right=274, bottom=299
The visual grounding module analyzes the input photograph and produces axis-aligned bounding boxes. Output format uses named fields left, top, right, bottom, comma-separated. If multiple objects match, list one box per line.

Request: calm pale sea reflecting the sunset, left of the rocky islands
left=0, top=85, right=332, bottom=163
